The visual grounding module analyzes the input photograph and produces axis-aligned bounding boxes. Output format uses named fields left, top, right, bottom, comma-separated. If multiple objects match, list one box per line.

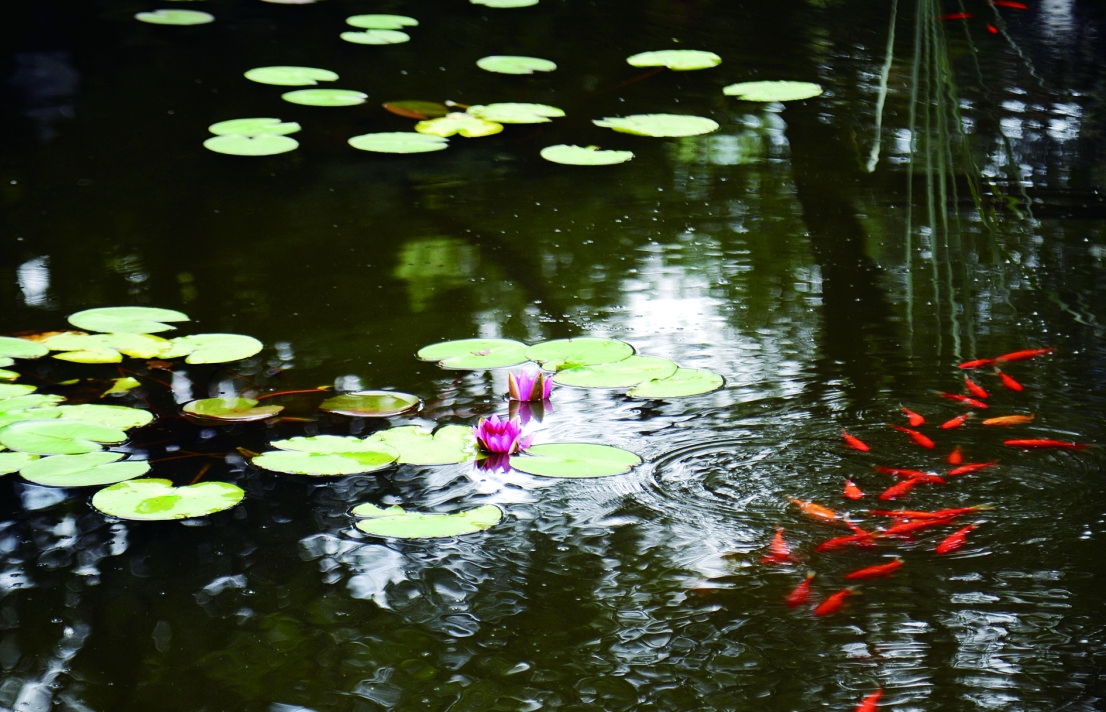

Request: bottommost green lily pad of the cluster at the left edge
left=92, top=479, right=246, bottom=521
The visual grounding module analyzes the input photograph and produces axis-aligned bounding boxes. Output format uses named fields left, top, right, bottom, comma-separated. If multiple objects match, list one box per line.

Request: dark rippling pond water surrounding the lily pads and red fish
left=0, top=0, right=1106, bottom=712
